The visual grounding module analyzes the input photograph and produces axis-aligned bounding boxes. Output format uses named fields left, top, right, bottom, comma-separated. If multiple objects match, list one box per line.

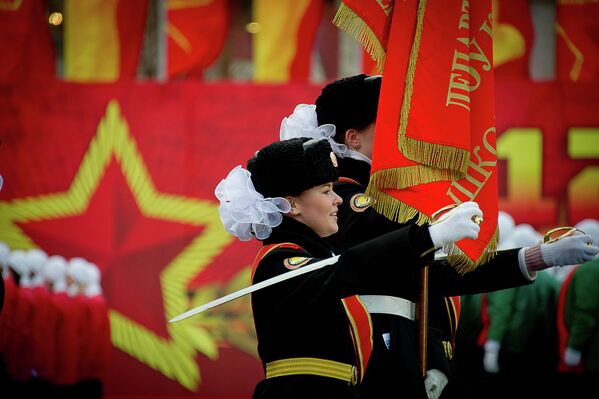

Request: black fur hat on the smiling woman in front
left=247, top=137, right=339, bottom=198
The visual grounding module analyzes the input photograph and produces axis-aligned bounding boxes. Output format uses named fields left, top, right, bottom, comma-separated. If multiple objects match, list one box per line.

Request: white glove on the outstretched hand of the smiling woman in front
left=428, top=201, right=483, bottom=248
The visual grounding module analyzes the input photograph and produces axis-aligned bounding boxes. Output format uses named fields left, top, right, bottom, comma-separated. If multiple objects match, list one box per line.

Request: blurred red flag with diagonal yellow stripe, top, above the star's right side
left=167, top=0, right=230, bottom=77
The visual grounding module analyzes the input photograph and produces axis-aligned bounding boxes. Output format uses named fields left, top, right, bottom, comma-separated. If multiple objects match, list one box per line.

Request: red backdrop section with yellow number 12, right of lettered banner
left=495, top=81, right=599, bottom=228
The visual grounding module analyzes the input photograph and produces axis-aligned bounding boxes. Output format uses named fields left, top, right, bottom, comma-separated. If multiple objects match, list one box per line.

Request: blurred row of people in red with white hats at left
left=0, top=242, right=112, bottom=398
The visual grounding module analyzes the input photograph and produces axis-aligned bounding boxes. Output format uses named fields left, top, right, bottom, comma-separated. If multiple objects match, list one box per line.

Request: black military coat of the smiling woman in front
left=252, top=217, right=432, bottom=398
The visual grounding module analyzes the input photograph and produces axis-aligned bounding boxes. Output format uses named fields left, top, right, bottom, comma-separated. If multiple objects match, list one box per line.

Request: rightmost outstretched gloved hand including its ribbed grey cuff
left=524, top=232, right=599, bottom=271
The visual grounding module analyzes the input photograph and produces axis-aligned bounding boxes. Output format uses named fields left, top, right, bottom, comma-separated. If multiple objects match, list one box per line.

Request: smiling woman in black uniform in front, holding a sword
left=215, top=138, right=482, bottom=399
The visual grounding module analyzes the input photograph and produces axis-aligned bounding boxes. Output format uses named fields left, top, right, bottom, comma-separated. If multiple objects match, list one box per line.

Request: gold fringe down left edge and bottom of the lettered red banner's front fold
left=397, top=0, right=470, bottom=177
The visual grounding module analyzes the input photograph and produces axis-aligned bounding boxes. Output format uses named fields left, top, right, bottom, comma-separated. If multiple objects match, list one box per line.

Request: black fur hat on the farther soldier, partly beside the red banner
left=316, top=74, right=382, bottom=143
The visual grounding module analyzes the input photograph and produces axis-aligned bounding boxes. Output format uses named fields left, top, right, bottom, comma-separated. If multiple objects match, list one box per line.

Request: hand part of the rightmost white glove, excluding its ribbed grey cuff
left=541, top=234, right=599, bottom=266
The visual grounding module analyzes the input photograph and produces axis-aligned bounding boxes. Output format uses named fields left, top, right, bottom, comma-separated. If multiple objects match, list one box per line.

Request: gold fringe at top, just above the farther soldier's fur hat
left=333, top=2, right=386, bottom=73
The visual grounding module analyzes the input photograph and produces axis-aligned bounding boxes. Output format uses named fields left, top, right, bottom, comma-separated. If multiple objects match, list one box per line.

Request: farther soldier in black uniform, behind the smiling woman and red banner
left=281, top=75, right=599, bottom=398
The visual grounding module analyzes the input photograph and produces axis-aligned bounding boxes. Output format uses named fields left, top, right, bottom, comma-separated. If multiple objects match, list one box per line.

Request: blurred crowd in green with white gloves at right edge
left=454, top=216, right=599, bottom=398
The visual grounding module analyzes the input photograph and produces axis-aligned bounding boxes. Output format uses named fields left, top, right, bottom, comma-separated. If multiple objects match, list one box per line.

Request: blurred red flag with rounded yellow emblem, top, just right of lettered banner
left=493, top=0, right=534, bottom=78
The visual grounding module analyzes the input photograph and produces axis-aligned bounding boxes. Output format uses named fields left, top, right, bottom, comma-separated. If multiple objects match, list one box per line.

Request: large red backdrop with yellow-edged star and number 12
left=0, top=81, right=599, bottom=398
